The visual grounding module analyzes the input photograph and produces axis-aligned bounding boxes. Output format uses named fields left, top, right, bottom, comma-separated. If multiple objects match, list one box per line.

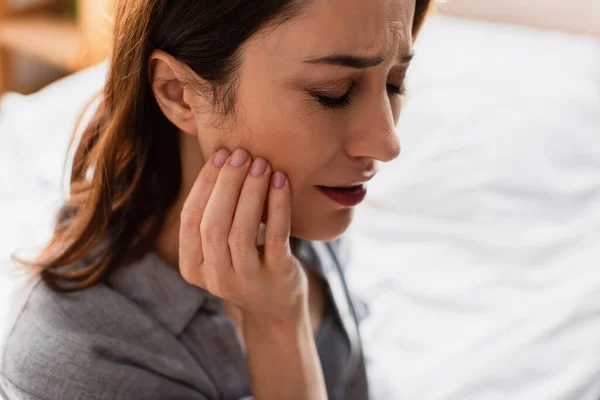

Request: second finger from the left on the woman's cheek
left=200, top=149, right=251, bottom=273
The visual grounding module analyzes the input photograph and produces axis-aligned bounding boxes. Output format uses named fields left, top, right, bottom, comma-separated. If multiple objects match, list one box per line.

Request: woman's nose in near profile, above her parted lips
left=345, top=96, right=400, bottom=162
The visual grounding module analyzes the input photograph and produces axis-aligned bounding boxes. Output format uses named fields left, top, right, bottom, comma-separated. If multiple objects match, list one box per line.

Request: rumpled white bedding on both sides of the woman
left=0, top=17, right=600, bottom=400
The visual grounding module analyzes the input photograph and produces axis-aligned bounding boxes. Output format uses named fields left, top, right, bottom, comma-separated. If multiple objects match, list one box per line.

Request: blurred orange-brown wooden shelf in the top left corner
left=0, top=0, right=114, bottom=93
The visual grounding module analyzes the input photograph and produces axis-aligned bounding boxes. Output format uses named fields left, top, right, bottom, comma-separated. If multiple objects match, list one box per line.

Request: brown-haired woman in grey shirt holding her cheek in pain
left=0, top=0, right=429, bottom=400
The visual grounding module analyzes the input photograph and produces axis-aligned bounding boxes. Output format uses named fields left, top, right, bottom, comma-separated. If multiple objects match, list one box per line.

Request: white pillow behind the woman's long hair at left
left=0, top=64, right=106, bottom=324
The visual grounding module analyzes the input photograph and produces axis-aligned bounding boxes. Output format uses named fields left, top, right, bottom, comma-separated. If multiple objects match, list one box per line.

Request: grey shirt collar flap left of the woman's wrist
left=107, top=252, right=223, bottom=335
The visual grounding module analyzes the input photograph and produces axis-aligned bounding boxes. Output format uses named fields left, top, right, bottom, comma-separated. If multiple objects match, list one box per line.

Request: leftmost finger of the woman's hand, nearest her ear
left=179, top=149, right=230, bottom=283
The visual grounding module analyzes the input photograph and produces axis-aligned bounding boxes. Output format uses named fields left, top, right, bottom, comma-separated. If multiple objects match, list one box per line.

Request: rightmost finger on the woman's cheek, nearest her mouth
left=265, top=171, right=292, bottom=267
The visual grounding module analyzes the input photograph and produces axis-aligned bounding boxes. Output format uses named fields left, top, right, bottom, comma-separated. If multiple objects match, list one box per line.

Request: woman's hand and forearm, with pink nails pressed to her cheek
left=179, top=149, right=327, bottom=400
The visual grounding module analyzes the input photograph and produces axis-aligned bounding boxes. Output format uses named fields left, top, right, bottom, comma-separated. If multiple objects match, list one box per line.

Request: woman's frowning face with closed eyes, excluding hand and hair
left=178, top=0, right=415, bottom=240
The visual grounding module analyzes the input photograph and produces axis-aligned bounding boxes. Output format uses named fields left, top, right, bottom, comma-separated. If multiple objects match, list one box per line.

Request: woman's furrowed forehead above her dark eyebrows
left=251, top=0, right=415, bottom=58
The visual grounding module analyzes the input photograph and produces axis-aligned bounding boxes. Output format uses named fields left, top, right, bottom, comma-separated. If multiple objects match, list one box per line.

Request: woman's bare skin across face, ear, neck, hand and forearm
left=150, top=0, right=414, bottom=399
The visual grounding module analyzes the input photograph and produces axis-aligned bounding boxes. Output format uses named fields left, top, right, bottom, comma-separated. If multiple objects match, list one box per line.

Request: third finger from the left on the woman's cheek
left=229, top=158, right=271, bottom=270
